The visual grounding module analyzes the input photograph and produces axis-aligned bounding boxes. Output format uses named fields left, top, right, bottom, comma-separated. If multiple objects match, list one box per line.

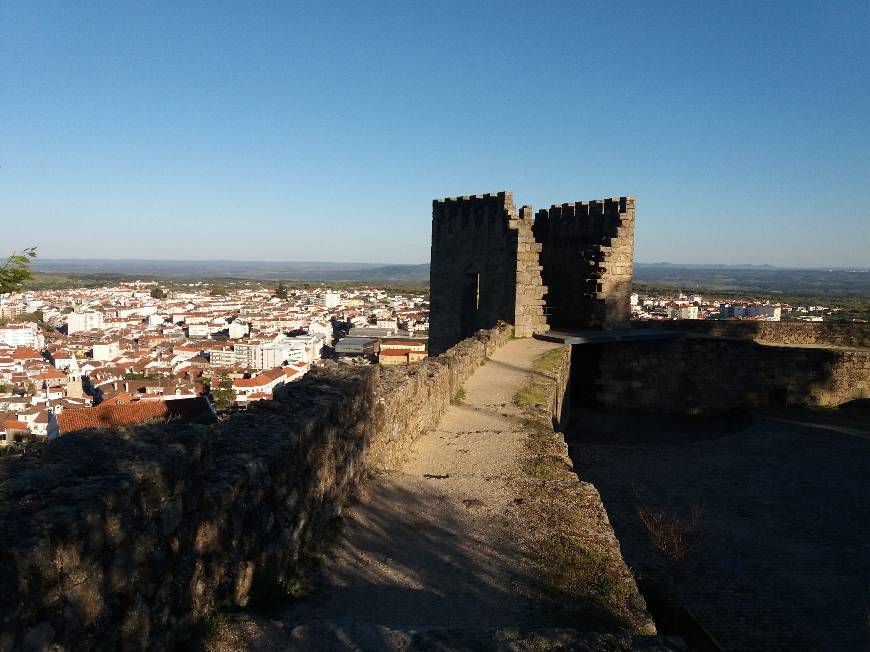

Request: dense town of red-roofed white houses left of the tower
left=0, top=282, right=428, bottom=446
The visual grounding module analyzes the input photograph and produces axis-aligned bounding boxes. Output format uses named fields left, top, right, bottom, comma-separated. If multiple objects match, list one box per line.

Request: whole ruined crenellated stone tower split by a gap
left=429, top=192, right=635, bottom=354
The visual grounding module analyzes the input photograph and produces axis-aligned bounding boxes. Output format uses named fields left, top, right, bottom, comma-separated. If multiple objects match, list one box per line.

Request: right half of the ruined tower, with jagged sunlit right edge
left=534, top=197, right=635, bottom=329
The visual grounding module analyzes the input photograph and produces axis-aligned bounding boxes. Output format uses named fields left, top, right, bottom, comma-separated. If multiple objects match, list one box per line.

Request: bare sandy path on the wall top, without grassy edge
left=282, top=339, right=558, bottom=630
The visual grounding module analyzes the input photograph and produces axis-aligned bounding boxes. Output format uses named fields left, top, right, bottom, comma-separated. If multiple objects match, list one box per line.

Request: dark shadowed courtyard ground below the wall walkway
left=568, top=402, right=870, bottom=650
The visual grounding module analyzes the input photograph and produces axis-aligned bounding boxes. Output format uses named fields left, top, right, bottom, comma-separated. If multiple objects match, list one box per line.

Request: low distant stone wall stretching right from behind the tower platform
left=631, top=319, right=870, bottom=348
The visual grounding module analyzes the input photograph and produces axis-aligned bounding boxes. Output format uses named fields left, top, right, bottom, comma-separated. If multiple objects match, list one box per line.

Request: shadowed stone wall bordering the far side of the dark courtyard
left=572, top=337, right=870, bottom=414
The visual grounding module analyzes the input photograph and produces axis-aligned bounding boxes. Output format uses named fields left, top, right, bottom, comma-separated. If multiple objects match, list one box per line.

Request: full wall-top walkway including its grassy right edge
left=207, top=339, right=660, bottom=652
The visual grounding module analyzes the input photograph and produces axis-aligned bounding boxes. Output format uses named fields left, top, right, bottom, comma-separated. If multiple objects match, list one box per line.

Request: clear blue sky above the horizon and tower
left=0, top=0, right=870, bottom=266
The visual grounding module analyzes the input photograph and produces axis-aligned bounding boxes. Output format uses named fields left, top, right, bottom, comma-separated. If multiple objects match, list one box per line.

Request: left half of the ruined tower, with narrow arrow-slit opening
left=429, top=192, right=547, bottom=354
